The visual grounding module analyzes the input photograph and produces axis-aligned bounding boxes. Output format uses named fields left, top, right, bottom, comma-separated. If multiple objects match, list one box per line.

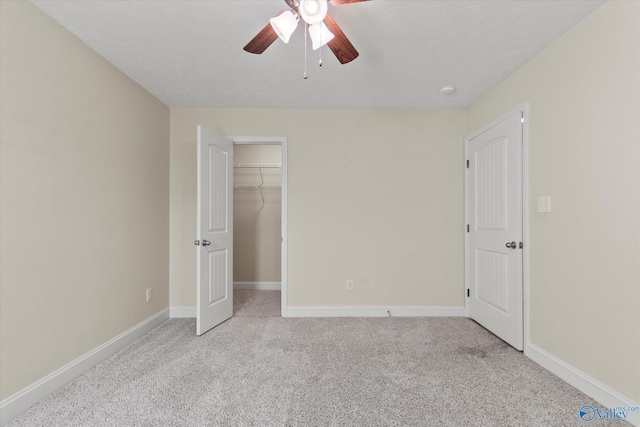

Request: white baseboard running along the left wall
left=0, top=308, right=169, bottom=424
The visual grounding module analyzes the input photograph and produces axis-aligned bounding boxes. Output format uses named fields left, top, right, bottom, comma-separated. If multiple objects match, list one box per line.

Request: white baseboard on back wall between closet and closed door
left=282, top=306, right=464, bottom=317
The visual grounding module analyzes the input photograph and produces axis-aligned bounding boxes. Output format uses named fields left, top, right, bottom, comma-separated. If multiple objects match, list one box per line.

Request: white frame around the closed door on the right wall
left=463, top=102, right=531, bottom=355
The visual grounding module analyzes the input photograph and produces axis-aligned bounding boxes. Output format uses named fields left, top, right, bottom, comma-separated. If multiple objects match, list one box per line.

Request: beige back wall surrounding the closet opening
left=171, top=109, right=465, bottom=307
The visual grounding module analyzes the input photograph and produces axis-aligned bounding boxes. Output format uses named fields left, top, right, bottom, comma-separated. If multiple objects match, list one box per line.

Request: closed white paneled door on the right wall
left=466, top=112, right=524, bottom=350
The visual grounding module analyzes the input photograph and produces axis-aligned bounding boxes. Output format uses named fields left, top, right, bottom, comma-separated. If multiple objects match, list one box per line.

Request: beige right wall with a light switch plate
left=467, top=1, right=640, bottom=402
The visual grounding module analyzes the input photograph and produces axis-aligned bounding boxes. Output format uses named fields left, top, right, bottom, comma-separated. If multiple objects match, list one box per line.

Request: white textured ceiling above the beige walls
left=32, top=0, right=604, bottom=108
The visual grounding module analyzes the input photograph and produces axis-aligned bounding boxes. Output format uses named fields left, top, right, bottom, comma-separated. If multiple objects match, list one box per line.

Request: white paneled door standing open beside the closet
left=195, top=126, right=233, bottom=335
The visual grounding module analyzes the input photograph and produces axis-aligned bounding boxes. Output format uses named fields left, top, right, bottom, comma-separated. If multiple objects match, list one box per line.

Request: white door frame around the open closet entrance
left=225, top=136, right=288, bottom=317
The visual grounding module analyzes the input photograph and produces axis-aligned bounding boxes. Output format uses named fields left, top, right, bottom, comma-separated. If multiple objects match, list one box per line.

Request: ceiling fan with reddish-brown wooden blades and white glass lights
left=244, top=0, right=367, bottom=64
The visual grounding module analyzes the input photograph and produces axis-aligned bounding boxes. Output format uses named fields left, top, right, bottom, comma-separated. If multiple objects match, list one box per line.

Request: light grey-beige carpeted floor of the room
left=7, top=291, right=620, bottom=427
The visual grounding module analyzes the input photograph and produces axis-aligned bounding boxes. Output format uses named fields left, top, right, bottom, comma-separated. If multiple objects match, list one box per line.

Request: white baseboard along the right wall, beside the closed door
left=524, top=344, right=640, bottom=426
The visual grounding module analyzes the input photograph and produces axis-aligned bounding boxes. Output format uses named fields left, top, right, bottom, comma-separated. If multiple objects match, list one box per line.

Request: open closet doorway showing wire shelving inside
left=228, top=137, right=287, bottom=316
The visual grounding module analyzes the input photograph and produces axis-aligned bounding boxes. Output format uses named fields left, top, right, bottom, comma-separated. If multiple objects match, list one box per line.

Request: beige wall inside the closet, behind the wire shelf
left=233, top=145, right=282, bottom=283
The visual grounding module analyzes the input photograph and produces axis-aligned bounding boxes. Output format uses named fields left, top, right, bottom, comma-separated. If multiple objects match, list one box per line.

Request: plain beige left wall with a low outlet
left=0, top=1, right=169, bottom=400
